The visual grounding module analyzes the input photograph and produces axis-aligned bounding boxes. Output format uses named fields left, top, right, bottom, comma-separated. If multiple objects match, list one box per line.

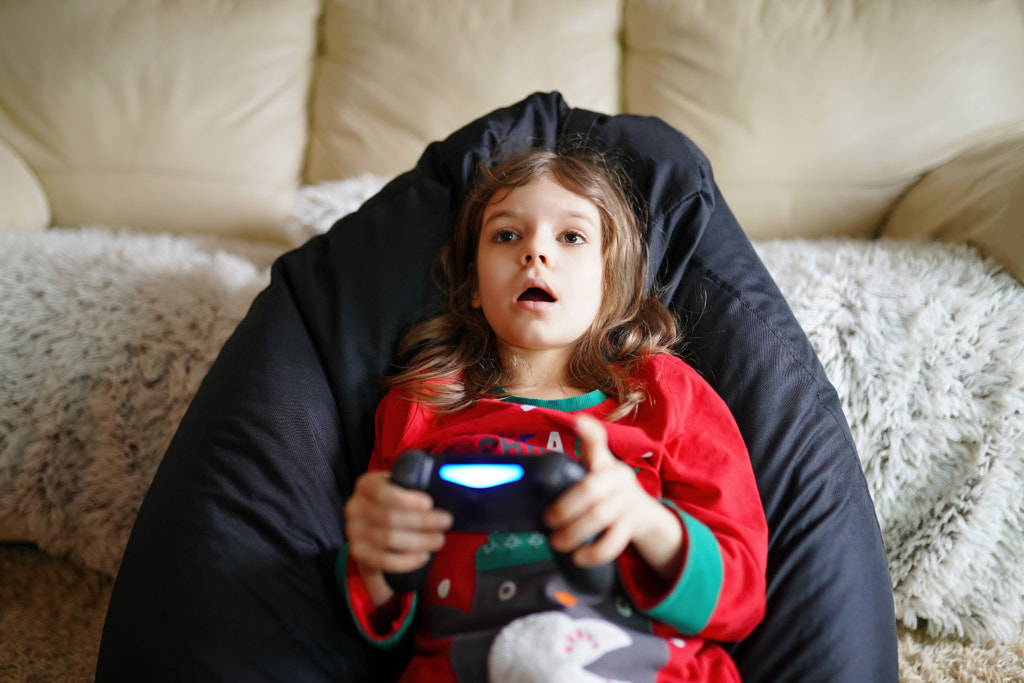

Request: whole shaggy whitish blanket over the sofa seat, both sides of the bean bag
left=0, top=176, right=1024, bottom=641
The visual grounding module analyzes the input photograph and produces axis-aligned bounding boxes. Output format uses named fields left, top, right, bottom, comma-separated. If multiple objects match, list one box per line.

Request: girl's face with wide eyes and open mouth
left=473, top=178, right=603, bottom=366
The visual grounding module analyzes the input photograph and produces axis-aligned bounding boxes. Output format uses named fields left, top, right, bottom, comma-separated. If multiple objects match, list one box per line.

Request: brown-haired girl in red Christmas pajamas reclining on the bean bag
left=337, top=151, right=767, bottom=681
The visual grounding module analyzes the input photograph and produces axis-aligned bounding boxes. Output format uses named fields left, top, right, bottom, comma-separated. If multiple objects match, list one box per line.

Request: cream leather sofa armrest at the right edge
left=882, top=122, right=1024, bottom=282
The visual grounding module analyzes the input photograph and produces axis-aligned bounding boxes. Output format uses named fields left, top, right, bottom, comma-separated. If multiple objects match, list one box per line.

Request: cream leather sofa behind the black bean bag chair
left=6, top=0, right=1024, bottom=276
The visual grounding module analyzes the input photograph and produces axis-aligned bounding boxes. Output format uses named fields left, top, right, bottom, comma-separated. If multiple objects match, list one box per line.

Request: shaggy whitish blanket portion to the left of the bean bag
left=0, top=228, right=280, bottom=574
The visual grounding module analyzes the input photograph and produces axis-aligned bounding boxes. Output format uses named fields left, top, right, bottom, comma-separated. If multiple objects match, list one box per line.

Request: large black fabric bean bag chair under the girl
left=96, top=93, right=898, bottom=683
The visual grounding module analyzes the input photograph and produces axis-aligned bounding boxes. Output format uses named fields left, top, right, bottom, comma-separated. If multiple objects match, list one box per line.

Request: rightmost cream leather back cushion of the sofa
left=623, top=0, right=1024, bottom=238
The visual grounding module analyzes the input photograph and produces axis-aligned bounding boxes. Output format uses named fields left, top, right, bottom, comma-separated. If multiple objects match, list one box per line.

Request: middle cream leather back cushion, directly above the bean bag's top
left=306, top=0, right=622, bottom=182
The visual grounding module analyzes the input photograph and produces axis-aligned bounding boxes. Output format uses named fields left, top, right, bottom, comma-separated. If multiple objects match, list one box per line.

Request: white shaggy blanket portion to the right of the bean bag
left=758, top=241, right=1024, bottom=641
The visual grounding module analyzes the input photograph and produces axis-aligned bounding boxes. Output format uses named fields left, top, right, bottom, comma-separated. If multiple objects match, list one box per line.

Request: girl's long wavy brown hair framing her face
left=383, top=150, right=677, bottom=420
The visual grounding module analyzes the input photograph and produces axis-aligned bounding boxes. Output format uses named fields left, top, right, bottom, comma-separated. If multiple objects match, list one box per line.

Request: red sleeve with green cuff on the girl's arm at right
left=620, top=356, right=768, bottom=641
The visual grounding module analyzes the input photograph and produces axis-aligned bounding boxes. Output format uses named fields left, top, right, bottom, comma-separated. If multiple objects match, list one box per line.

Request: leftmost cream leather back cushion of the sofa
left=0, top=0, right=319, bottom=244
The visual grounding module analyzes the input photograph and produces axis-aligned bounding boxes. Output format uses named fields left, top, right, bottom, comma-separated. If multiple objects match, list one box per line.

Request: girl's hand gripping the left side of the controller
left=345, top=471, right=452, bottom=605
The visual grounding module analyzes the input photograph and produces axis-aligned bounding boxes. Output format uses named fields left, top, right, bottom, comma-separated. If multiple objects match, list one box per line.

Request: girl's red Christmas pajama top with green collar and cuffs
left=336, top=354, right=768, bottom=681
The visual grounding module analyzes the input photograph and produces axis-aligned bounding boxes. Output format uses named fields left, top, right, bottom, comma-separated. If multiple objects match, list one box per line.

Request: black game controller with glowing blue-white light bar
left=384, top=451, right=615, bottom=596
